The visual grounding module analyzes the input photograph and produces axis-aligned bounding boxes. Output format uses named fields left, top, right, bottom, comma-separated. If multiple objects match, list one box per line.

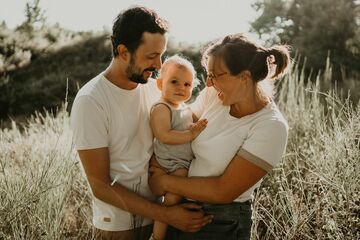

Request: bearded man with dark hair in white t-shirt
left=71, top=7, right=210, bottom=239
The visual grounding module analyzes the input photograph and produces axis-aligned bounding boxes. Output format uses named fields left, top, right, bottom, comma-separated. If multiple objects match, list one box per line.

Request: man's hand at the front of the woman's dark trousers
left=166, top=203, right=214, bottom=232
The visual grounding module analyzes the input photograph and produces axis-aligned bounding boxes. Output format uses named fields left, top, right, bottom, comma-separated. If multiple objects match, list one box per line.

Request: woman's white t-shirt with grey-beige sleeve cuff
left=189, top=87, right=288, bottom=202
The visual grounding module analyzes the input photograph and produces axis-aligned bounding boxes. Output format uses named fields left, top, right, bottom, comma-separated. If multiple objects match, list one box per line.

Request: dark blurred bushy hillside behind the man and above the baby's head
left=0, top=0, right=203, bottom=120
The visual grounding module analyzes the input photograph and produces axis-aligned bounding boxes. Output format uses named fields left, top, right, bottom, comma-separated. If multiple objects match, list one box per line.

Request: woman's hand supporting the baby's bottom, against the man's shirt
left=148, top=155, right=167, bottom=196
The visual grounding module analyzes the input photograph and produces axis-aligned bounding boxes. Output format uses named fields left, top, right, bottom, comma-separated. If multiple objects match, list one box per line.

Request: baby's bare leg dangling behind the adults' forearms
left=153, top=168, right=188, bottom=240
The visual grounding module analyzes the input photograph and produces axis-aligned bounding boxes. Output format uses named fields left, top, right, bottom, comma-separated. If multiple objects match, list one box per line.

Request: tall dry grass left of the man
left=0, top=111, right=92, bottom=240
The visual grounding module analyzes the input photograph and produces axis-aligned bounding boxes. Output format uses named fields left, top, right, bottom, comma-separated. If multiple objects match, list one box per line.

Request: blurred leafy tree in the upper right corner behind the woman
left=251, top=0, right=360, bottom=80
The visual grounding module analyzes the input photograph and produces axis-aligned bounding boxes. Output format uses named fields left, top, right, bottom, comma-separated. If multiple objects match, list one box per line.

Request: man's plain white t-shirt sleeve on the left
left=70, top=96, right=108, bottom=150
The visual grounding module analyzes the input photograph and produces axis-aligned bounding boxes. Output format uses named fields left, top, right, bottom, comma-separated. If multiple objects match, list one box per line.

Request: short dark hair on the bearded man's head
left=111, top=6, right=168, bottom=57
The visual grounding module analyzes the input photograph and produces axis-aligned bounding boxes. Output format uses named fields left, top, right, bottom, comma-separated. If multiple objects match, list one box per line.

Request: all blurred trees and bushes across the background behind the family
left=0, top=0, right=360, bottom=120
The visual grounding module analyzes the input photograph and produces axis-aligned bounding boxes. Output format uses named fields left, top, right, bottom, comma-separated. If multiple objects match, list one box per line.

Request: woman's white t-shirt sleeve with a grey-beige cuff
left=237, top=120, right=288, bottom=172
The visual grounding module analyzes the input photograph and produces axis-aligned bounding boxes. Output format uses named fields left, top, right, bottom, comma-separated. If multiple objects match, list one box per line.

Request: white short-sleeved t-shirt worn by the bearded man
left=71, top=74, right=160, bottom=231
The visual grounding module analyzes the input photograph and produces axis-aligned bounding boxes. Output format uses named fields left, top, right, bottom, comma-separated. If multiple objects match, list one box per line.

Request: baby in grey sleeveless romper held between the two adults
left=150, top=55, right=207, bottom=240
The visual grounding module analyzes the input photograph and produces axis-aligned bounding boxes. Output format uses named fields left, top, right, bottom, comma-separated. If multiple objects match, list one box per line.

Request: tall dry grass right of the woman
left=253, top=62, right=360, bottom=239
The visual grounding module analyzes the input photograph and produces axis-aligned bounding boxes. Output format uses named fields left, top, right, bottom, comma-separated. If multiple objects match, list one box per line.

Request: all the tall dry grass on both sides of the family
left=0, top=62, right=360, bottom=239
